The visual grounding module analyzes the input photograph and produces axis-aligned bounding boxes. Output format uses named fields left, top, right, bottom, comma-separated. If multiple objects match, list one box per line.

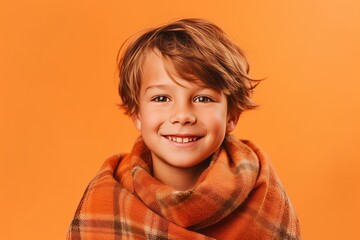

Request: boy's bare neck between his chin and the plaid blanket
left=153, top=156, right=210, bottom=191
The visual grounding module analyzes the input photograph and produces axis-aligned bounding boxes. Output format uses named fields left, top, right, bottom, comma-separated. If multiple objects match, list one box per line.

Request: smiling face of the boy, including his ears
left=133, top=51, right=237, bottom=168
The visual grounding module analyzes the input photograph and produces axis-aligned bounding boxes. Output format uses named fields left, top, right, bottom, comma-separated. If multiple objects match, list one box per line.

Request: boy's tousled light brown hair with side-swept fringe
left=118, top=18, right=259, bottom=116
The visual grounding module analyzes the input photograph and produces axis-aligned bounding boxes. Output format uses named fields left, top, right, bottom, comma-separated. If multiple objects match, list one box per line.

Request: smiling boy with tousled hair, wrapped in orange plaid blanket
left=68, top=19, right=300, bottom=239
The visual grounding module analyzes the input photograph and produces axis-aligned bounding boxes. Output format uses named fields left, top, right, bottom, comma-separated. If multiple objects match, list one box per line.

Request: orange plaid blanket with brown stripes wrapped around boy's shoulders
left=67, top=135, right=300, bottom=240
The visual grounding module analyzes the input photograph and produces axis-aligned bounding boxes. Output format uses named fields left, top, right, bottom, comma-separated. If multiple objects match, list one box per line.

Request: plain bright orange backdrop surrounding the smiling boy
left=0, top=0, right=360, bottom=240
